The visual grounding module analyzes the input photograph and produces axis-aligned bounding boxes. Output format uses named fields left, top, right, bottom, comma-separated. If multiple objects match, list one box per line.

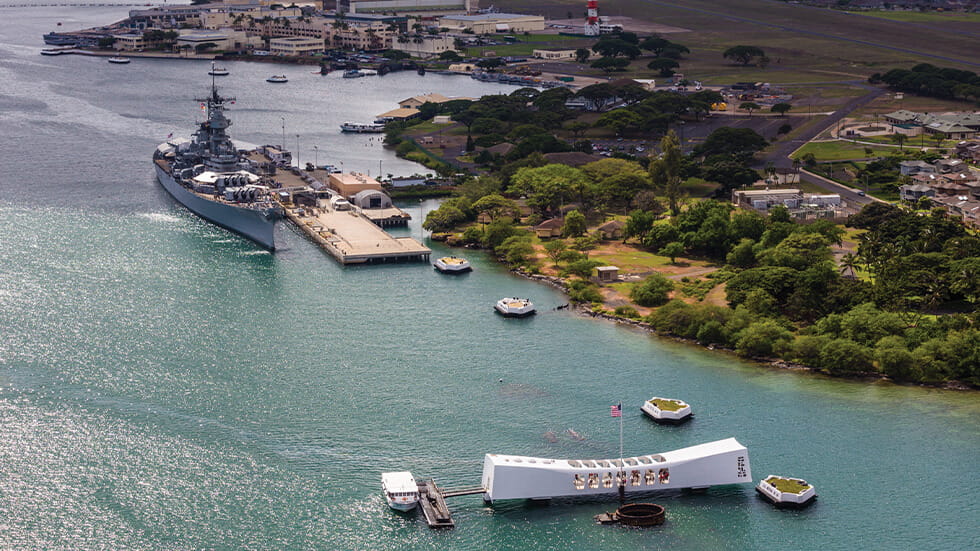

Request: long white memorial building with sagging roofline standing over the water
left=482, top=438, right=752, bottom=502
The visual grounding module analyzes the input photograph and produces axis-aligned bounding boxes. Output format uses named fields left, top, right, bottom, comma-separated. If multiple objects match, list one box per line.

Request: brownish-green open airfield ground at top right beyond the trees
left=494, top=0, right=980, bottom=84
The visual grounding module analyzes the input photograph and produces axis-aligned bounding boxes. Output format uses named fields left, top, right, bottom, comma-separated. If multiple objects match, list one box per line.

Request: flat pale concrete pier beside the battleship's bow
left=286, top=208, right=432, bottom=264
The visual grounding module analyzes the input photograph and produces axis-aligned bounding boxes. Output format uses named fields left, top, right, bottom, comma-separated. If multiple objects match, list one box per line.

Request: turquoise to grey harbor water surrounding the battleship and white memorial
left=0, top=2, right=980, bottom=550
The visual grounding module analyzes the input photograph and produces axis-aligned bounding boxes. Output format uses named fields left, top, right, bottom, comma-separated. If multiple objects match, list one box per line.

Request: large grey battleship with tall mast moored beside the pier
left=153, top=76, right=292, bottom=250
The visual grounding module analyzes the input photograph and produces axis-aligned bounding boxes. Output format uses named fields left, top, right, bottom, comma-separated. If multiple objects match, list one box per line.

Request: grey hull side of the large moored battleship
left=154, top=163, right=279, bottom=251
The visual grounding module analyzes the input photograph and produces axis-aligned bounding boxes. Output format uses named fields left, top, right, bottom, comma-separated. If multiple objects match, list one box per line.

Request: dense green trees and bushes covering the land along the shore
left=400, top=74, right=980, bottom=392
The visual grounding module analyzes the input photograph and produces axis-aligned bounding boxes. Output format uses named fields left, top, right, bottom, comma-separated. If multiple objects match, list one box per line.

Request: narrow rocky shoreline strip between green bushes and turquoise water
left=510, top=268, right=980, bottom=392
